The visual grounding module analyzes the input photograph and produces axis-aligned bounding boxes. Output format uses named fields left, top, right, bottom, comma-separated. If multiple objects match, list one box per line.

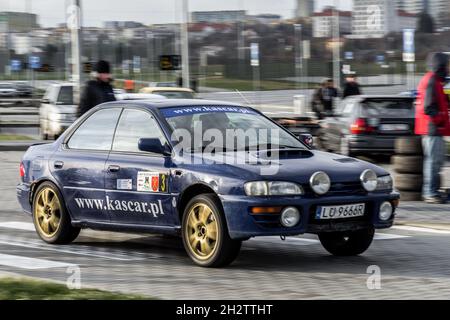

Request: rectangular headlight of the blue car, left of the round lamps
left=244, top=181, right=304, bottom=196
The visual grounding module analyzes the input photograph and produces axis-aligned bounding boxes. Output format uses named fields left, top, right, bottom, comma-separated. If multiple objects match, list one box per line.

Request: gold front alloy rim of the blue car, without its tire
left=185, top=203, right=218, bottom=260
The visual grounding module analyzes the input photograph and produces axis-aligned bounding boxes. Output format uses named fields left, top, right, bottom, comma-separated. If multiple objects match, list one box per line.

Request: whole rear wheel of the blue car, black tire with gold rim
left=32, top=182, right=81, bottom=244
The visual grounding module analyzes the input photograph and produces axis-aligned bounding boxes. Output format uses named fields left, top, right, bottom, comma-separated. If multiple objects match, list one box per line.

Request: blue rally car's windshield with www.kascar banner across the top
left=162, top=106, right=307, bottom=151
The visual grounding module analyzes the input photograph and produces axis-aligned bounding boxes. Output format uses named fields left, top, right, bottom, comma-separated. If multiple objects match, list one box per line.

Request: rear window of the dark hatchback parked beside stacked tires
left=361, top=99, right=414, bottom=117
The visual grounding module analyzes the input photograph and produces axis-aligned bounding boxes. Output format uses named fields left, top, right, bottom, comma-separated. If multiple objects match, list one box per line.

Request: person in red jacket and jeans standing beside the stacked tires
left=415, top=53, right=450, bottom=203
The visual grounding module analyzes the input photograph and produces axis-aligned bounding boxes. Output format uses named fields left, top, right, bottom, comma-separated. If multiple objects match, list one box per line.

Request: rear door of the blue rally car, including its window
left=50, top=107, right=122, bottom=222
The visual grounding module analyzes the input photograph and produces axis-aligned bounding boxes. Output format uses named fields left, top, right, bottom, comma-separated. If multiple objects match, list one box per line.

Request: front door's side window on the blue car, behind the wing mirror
left=113, top=109, right=166, bottom=152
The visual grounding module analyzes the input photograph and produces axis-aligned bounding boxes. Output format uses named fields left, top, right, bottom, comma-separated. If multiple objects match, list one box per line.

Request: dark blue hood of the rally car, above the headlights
left=186, top=150, right=389, bottom=183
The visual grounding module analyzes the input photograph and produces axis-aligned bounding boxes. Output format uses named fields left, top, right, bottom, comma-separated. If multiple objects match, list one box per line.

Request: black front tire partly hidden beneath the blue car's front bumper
left=319, top=227, right=375, bottom=256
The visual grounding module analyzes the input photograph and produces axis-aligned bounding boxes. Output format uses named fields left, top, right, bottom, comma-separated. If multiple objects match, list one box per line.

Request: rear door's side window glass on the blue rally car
left=67, top=108, right=122, bottom=151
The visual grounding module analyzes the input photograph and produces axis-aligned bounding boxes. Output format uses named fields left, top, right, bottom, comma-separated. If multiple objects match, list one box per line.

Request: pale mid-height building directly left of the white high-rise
left=312, top=7, right=352, bottom=38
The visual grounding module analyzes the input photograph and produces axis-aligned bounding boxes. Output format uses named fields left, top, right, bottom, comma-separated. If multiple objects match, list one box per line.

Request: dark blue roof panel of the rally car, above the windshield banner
left=99, top=99, right=251, bottom=110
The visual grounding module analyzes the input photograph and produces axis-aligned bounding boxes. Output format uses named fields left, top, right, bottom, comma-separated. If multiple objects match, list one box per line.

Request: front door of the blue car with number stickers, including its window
left=105, top=108, right=176, bottom=226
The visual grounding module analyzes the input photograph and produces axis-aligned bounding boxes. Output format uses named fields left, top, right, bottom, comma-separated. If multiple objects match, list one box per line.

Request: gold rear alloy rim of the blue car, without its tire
left=34, top=188, right=61, bottom=238
